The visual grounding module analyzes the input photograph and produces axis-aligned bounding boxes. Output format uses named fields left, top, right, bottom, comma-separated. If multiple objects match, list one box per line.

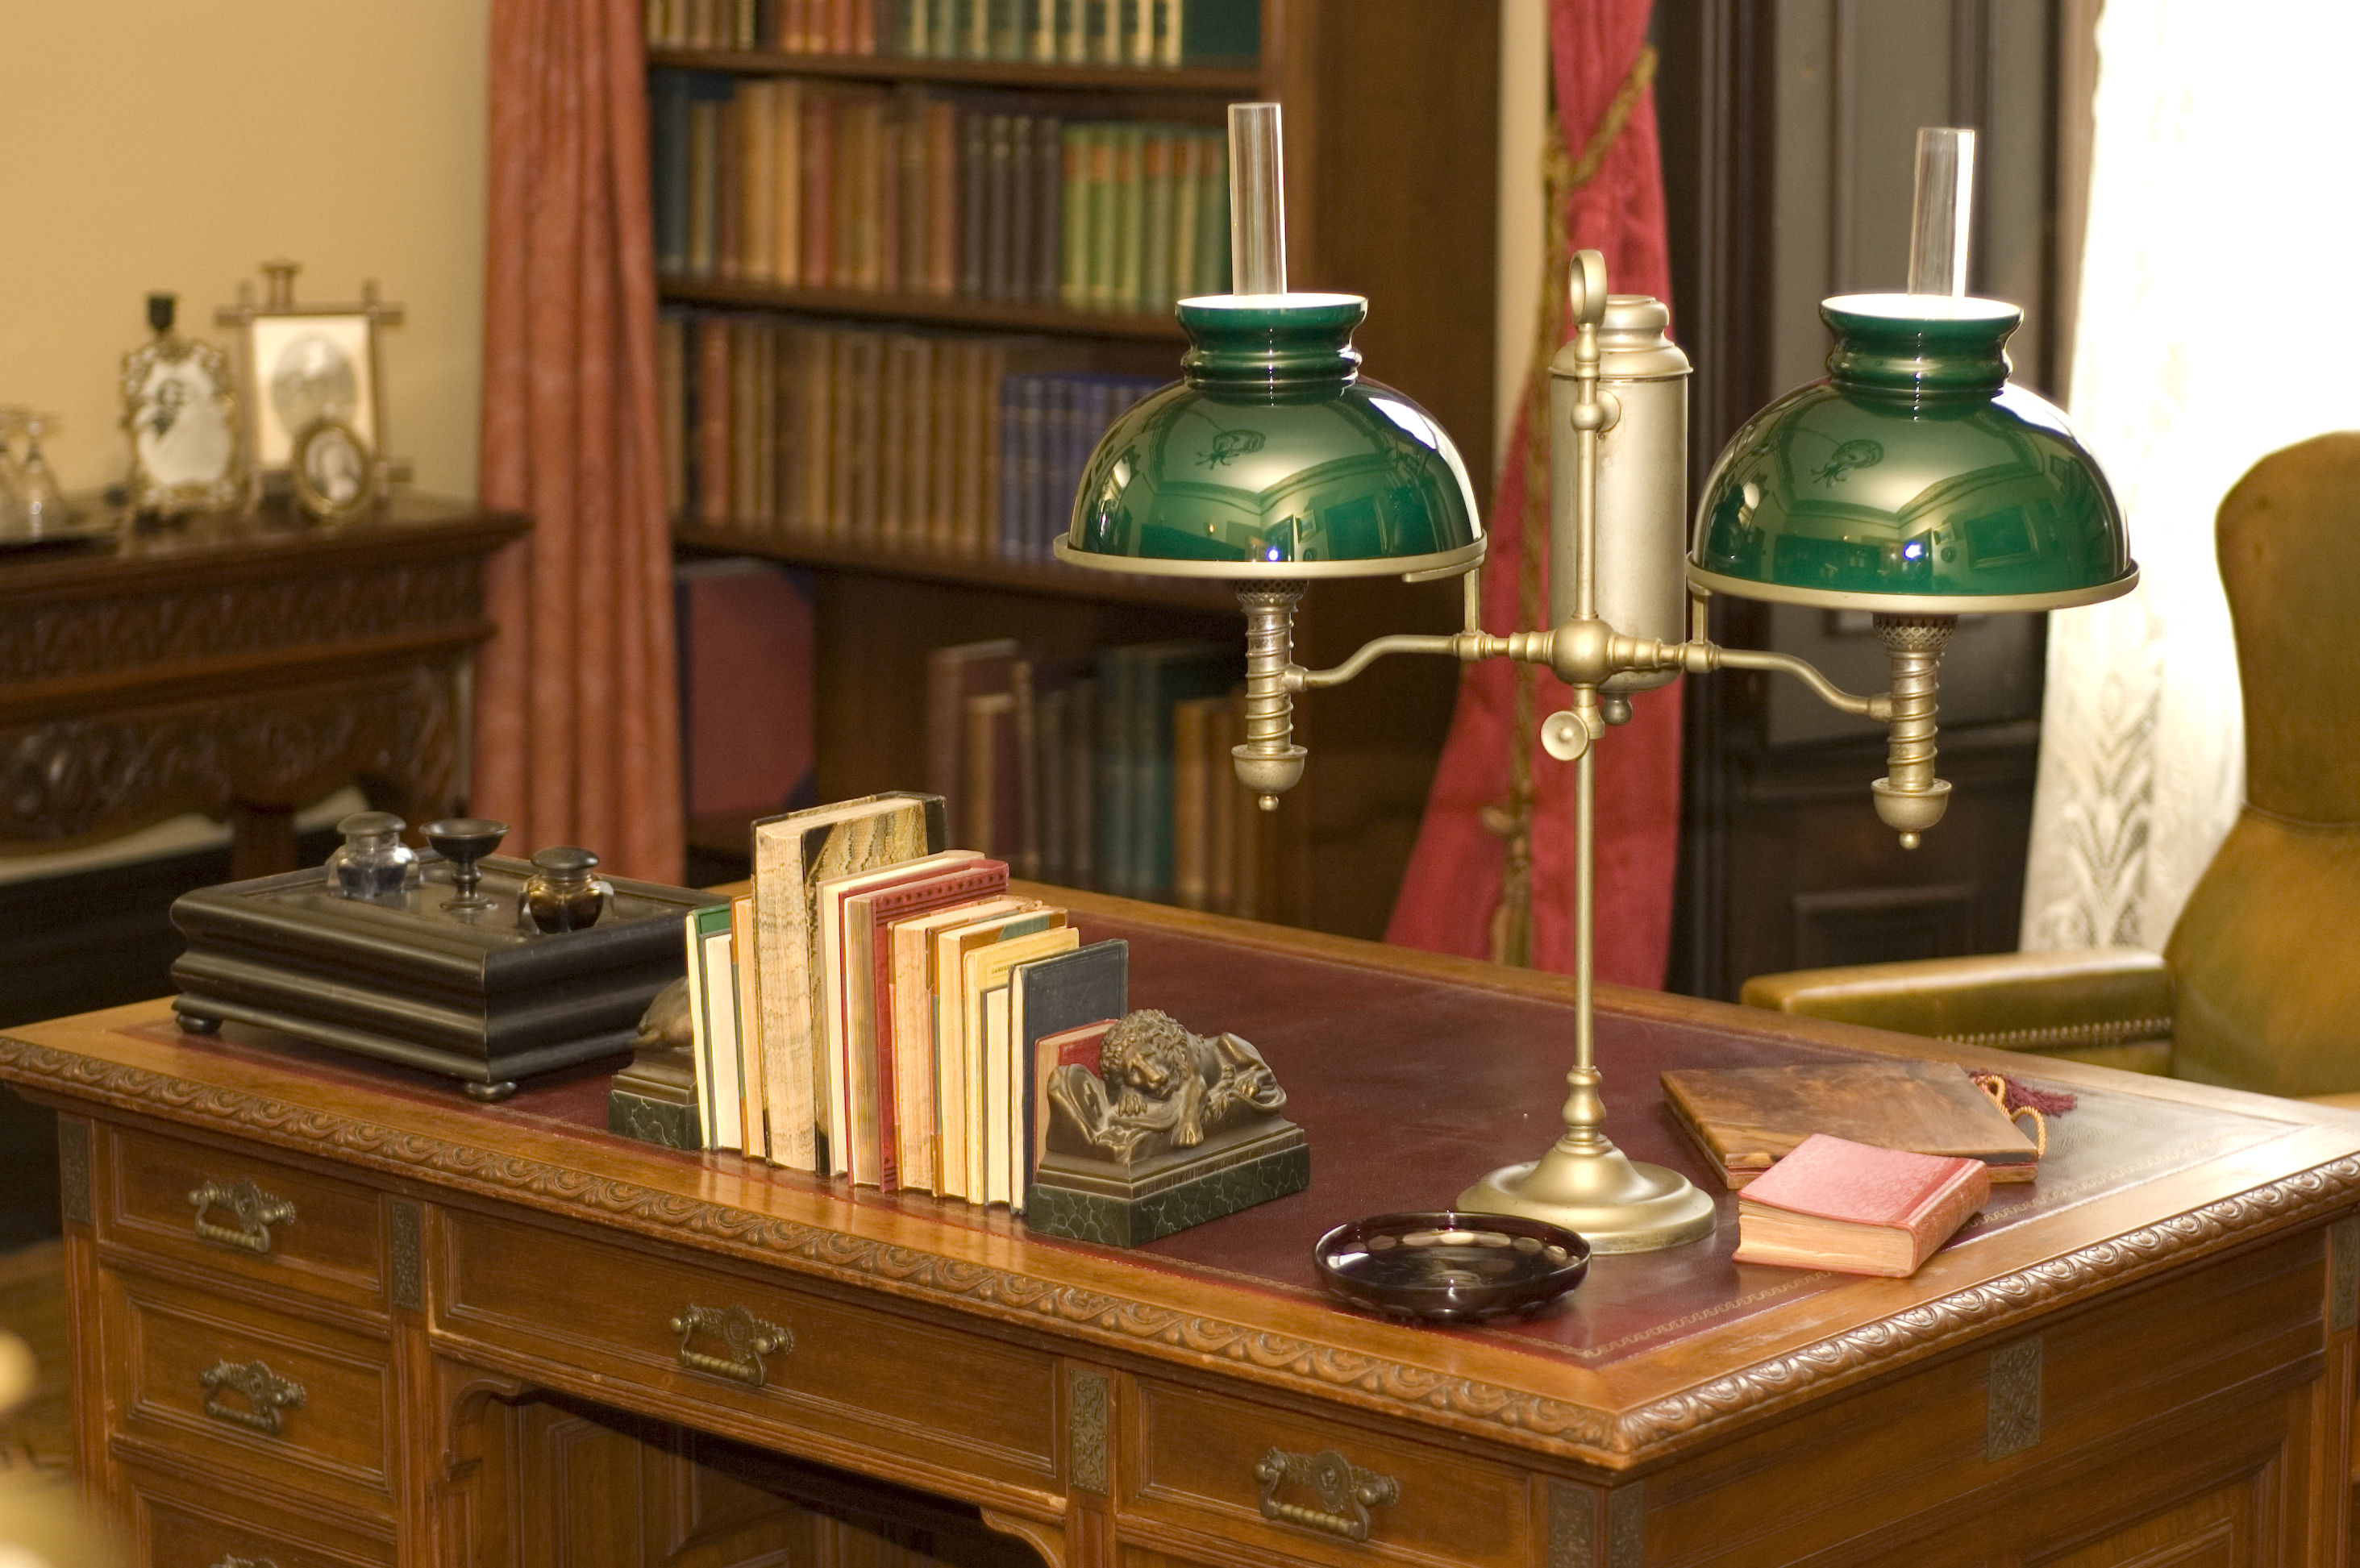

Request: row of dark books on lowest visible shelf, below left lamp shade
left=925, top=639, right=1270, bottom=917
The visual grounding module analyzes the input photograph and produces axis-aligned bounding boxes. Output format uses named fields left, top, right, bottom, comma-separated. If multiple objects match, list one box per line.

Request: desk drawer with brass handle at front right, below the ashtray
left=1118, top=1379, right=1538, bottom=1568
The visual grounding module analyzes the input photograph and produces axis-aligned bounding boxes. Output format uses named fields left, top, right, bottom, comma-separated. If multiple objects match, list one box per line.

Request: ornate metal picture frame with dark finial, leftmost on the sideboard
left=123, top=332, right=245, bottom=517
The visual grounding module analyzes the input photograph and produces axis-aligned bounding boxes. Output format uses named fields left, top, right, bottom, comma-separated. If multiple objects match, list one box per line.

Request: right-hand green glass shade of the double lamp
left=1688, top=295, right=2138, bottom=615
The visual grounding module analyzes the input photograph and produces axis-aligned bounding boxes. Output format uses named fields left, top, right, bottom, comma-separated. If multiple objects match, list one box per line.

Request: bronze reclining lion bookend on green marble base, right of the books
left=1024, top=1009, right=1312, bottom=1247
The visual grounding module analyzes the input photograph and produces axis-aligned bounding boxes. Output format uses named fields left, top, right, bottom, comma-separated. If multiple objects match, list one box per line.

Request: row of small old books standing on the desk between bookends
left=687, top=795, right=1128, bottom=1209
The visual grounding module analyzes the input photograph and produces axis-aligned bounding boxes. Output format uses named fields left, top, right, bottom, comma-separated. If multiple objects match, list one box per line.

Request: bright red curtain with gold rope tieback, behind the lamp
left=1385, top=0, right=1680, bottom=988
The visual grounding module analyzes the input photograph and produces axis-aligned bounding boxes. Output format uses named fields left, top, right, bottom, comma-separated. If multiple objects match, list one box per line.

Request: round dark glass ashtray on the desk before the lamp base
left=1312, top=1212, right=1591, bottom=1323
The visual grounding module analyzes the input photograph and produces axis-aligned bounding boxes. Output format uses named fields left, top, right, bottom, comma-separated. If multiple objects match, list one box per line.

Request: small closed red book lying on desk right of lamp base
left=1737, top=1132, right=1992, bottom=1278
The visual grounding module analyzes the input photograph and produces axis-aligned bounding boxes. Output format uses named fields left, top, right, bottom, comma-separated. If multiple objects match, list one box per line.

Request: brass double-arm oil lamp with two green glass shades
left=1055, top=104, right=2138, bottom=1252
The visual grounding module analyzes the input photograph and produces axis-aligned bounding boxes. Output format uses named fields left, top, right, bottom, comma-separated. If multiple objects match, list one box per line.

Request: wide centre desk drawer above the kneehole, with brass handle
left=435, top=1209, right=1055, bottom=1490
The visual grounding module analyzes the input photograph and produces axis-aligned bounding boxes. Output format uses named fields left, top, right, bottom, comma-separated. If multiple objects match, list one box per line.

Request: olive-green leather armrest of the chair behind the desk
left=1742, top=948, right=2171, bottom=1071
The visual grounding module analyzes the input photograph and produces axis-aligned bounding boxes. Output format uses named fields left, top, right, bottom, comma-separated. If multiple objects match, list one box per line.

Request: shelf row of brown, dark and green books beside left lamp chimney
left=649, top=71, right=1230, bottom=314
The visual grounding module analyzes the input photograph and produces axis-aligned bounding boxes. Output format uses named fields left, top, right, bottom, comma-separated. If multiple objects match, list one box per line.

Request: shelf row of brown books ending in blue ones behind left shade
left=656, top=311, right=1159, bottom=561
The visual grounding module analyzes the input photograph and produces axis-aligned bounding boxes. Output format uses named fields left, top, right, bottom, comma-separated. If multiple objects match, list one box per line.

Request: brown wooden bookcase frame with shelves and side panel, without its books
left=649, top=0, right=1499, bottom=936
